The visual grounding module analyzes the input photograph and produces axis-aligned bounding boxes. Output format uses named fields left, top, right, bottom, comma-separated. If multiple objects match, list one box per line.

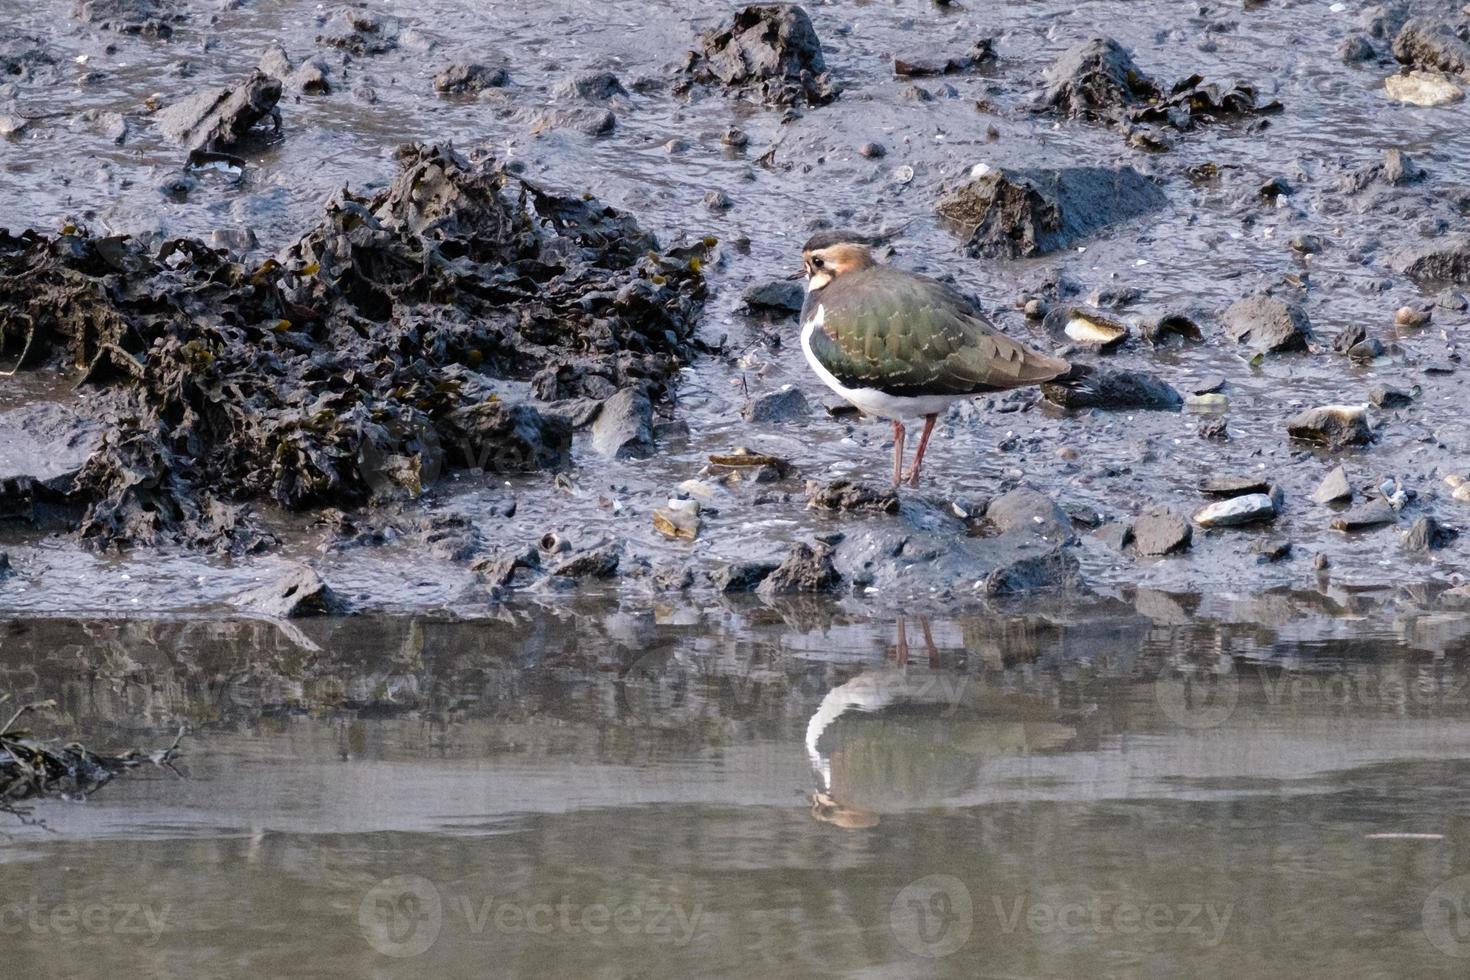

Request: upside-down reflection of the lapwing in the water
left=806, top=617, right=1076, bottom=830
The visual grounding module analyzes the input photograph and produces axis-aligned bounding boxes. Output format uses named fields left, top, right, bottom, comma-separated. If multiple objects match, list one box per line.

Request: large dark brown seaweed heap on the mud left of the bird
left=0, top=144, right=704, bottom=551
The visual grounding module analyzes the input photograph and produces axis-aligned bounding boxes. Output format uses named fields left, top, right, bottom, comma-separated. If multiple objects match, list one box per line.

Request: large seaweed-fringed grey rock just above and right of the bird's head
left=938, top=167, right=1167, bottom=259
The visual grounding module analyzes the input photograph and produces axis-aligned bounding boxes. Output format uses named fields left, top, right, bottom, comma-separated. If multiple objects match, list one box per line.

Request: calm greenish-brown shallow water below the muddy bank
left=0, top=605, right=1470, bottom=977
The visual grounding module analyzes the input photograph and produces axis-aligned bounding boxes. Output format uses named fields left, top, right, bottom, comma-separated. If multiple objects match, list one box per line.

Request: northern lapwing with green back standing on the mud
left=792, top=232, right=1079, bottom=486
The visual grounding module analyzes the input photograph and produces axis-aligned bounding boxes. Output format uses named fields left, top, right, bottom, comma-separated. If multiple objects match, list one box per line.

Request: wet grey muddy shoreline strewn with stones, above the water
left=0, top=3, right=1470, bottom=617
